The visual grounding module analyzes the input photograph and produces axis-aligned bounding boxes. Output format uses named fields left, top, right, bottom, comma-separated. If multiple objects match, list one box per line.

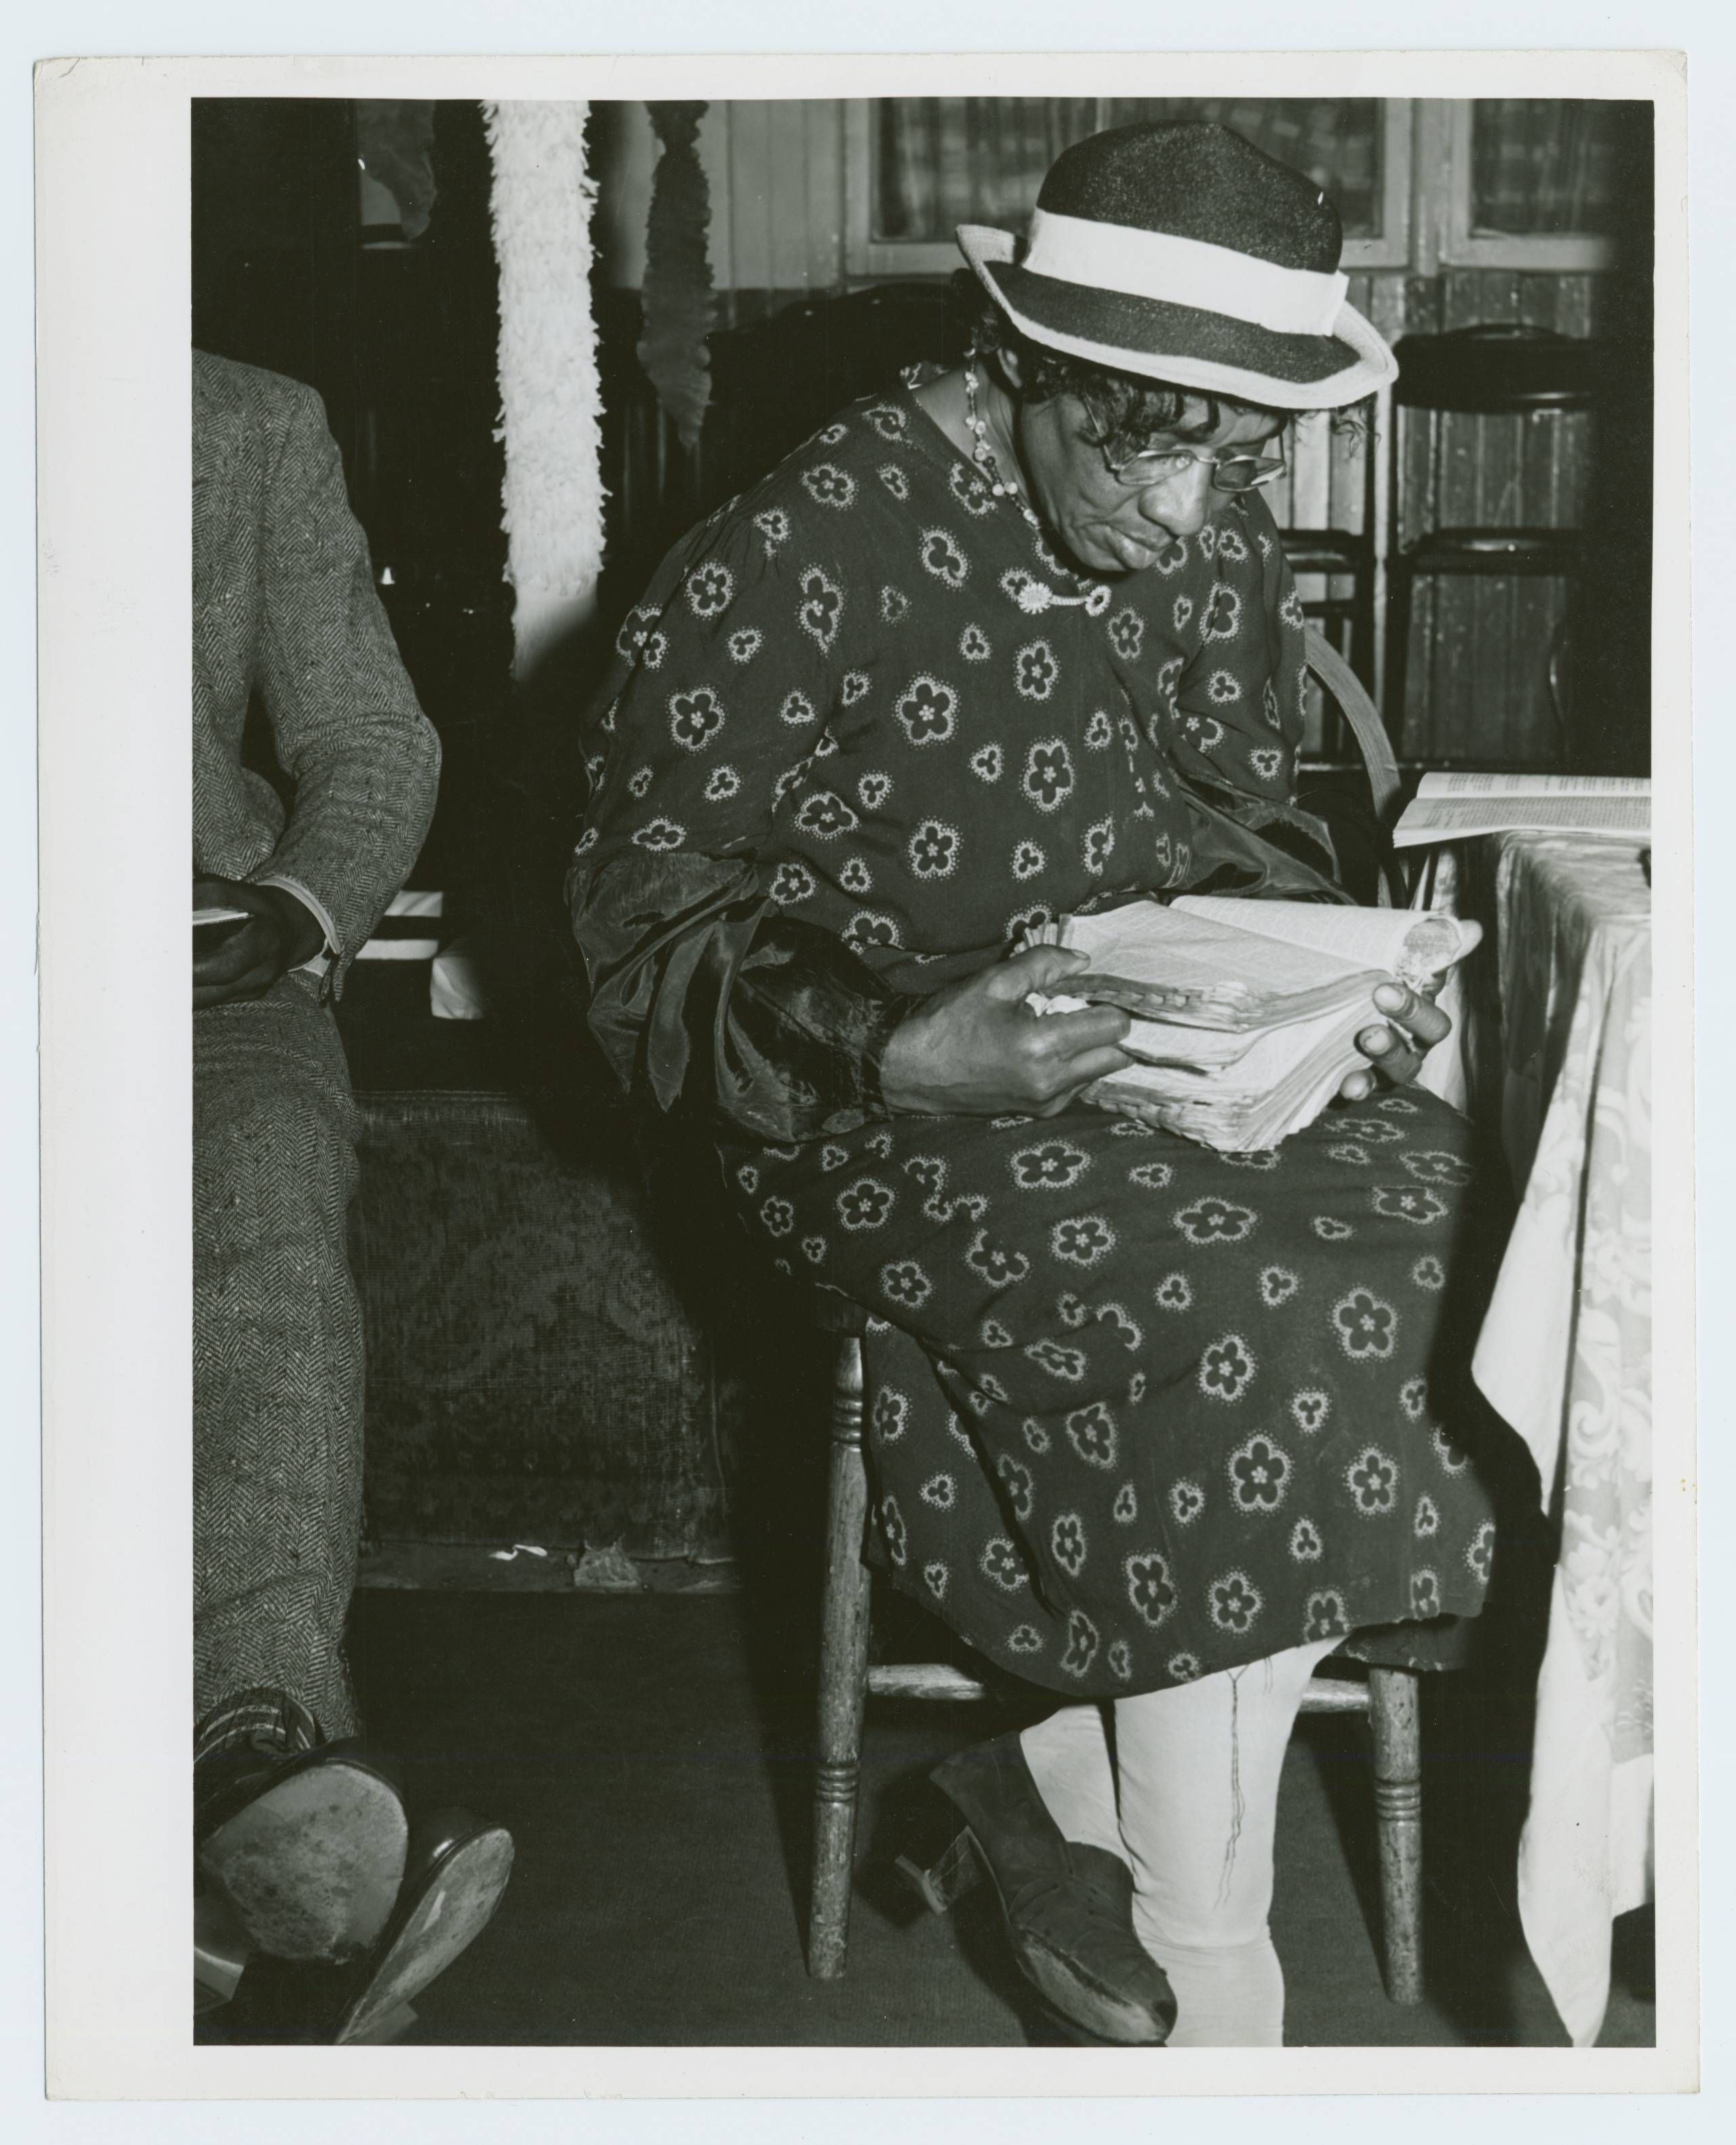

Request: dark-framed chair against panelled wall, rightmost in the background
left=1386, top=321, right=1601, bottom=747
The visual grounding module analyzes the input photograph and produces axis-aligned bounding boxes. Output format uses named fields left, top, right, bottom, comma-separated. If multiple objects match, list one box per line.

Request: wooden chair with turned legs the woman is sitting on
left=807, top=648, right=1423, bottom=2003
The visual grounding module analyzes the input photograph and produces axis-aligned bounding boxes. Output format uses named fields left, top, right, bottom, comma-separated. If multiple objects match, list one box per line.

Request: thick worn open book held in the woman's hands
left=1032, top=894, right=1483, bottom=1154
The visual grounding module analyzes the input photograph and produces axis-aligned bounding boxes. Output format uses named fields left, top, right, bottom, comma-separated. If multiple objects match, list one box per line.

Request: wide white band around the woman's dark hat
left=1008, top=208, right=1349, bottom=334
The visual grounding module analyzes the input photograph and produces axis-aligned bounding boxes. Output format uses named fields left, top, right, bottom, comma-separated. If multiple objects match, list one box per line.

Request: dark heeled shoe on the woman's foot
left=931, top=1735, right=1176, bottom=2049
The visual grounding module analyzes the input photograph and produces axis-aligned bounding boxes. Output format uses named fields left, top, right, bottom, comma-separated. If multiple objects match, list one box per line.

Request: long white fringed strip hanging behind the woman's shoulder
left=483, top=103, right=603, bottom=678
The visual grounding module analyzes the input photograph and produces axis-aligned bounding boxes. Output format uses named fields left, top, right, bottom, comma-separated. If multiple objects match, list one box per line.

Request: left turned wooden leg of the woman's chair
left=807, top=1339, right=869, bottom=1982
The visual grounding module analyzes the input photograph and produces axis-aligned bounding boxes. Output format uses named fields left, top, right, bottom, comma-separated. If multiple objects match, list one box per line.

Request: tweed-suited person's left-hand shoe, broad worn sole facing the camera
left=195, top=1741, right=410, bottom=1963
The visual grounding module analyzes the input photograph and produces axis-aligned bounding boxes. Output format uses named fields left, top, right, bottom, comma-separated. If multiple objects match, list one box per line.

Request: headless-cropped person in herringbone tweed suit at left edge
left=193, top=352, right=511, bottom=2038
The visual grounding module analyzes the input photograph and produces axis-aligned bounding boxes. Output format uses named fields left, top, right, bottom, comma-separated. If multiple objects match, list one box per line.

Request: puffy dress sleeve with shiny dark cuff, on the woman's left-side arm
left=566, top=506, right=914, bottom=1139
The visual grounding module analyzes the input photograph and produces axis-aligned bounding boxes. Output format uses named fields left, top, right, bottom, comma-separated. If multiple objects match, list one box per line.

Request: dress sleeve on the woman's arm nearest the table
left=1172, top=493, right=1347, bottom=901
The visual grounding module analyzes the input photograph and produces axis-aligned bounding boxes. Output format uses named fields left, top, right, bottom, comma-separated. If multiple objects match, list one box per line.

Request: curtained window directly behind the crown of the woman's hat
left=846, top=96, right=1410, bottom=277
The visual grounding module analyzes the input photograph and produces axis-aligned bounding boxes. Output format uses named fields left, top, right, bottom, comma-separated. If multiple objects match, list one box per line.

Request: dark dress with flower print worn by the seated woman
left=569, top=382, right=1493, bottom=1697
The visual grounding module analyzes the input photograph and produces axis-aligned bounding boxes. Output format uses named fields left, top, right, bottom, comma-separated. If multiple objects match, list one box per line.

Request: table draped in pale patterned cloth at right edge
left=1425, top=834, right=1653, bottom=2047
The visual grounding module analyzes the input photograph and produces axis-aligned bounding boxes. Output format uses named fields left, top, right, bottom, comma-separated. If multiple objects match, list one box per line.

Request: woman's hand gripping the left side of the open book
left=880, top=946, right=1133, bottom=1118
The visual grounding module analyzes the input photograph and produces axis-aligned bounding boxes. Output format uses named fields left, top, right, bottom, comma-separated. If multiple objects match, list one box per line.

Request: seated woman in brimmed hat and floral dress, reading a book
left=569, top=124, right=1493, bottom=2047
